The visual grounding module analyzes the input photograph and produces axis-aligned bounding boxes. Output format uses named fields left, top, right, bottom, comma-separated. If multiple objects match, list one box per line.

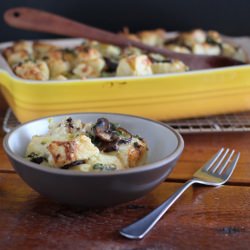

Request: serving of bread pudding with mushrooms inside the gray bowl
left=25, top=117, right=148, bottom=172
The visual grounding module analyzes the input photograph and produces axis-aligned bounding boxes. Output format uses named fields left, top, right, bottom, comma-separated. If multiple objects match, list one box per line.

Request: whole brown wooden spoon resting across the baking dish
left=4, top=7, right=245, bottom=70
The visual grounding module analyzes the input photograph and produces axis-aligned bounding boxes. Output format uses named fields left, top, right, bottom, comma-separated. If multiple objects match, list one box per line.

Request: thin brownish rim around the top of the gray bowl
left=3, top=112, right=184, bottom=177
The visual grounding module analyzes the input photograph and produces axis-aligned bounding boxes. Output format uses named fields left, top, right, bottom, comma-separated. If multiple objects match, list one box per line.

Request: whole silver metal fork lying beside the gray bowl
left=120, top=148, right=240, bottom=239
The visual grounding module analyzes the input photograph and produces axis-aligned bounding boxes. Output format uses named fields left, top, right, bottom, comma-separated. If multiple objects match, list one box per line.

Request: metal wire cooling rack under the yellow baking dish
left=3, top=109, right=250, bottom=134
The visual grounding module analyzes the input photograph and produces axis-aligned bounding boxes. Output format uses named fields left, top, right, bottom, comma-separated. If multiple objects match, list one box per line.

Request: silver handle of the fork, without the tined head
left=120, top=179, right=196, bottom=239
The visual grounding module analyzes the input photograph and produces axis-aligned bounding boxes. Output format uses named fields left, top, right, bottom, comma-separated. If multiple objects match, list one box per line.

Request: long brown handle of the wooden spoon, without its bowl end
left=1, top=7, right=185, bottom=59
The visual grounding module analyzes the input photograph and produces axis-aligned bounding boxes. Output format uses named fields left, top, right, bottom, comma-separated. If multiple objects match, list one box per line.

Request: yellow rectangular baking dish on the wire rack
left=0, top=39, right=250, bottom=122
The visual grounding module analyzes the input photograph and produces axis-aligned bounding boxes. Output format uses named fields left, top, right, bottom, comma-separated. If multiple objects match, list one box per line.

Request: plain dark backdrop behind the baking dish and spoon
left=0, top=0, right=250, bottom=42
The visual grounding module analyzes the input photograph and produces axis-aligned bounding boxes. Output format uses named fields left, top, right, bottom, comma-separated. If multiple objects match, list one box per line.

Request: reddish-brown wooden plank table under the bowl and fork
left=0, top=94, right=250, bottom=250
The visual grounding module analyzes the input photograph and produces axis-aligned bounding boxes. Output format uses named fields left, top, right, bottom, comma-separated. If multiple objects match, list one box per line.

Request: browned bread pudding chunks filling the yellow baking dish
left=2, top=29, right=247, bottom=81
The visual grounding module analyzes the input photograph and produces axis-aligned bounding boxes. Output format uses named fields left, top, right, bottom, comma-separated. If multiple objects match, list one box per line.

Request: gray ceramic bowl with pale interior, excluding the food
left=3, top=113, right=184, bottom=207
